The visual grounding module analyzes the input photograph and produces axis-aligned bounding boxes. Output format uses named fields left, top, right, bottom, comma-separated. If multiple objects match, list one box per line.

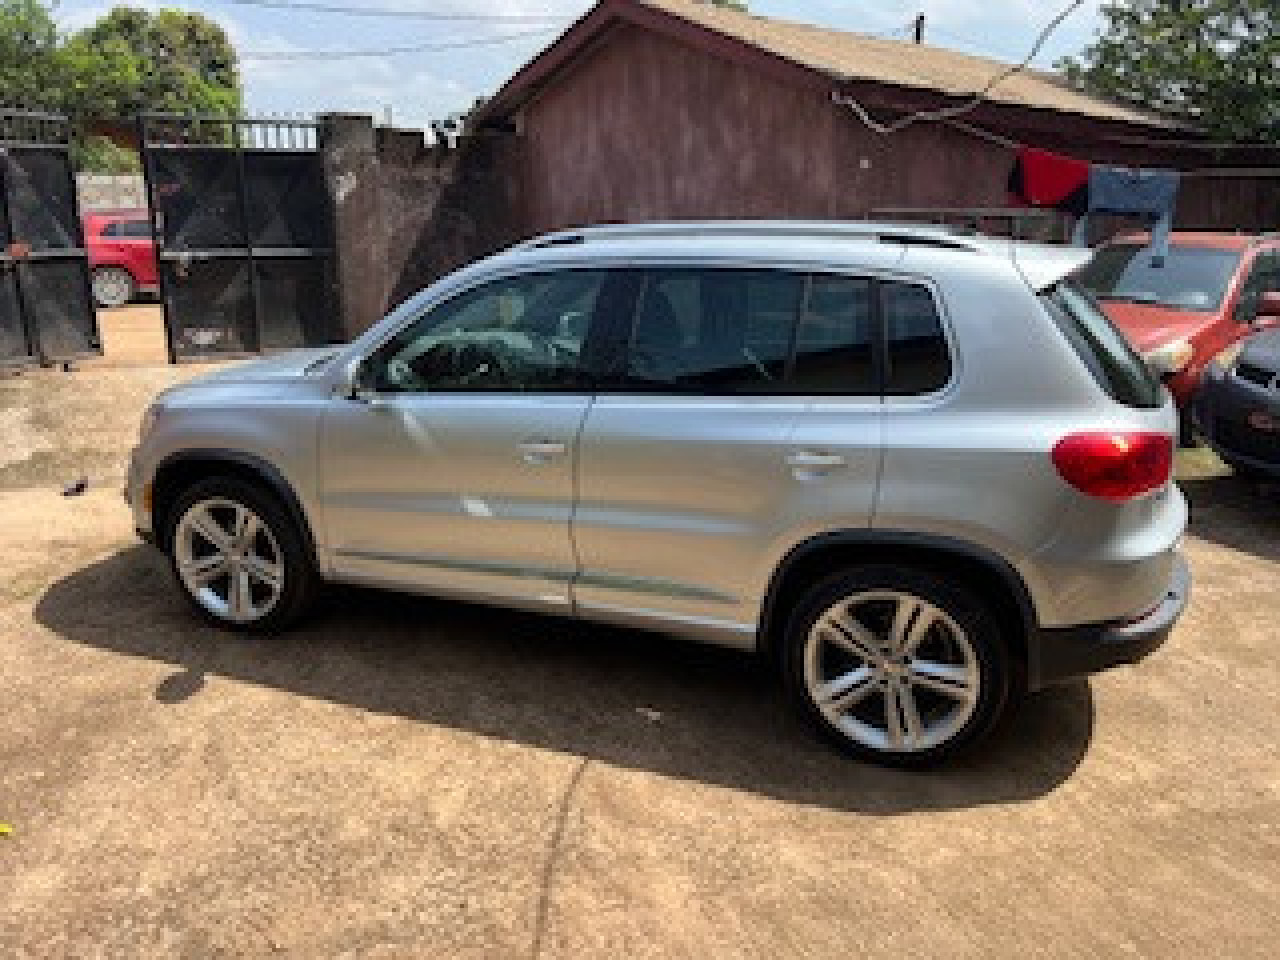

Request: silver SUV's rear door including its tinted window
left=573, top=266, right=881, bottom=646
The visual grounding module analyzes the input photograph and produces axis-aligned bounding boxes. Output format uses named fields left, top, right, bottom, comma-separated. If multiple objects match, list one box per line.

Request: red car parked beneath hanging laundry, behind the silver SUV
left=1079, top=233, right=1280, bottom=410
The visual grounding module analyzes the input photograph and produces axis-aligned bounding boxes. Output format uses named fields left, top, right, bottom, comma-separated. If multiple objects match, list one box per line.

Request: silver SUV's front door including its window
left=320, top=270, right=604, bottom=609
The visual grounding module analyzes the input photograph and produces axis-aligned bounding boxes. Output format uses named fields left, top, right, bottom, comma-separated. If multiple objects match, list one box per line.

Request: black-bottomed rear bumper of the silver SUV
left=1027, top=556, right=1192, bottom=691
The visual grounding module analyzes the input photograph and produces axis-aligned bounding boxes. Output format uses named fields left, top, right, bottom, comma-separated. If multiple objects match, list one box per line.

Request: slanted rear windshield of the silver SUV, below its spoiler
left=1041, top=280, right=1164, bottom=410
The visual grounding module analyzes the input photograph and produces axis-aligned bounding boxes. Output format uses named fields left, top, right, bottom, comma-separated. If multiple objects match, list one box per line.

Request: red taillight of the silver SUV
left=1053, top=430, right=1174, bottom=503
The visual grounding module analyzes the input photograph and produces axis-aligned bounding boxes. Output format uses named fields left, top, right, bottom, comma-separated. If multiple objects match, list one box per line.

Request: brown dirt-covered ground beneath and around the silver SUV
left=0, top=312, right=1280, bottom=957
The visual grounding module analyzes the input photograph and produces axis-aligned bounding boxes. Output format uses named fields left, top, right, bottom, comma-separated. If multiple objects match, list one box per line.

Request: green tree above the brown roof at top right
left=1059, top=0, right=1280, bottom=142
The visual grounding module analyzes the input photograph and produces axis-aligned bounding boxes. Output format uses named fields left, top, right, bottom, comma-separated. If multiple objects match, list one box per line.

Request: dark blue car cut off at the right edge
left=1194, top=330, right=1280, bottom=480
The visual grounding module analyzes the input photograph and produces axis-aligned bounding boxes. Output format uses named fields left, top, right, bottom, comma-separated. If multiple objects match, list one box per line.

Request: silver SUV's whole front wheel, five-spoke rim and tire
left=166, top=477, right=319, bottom=632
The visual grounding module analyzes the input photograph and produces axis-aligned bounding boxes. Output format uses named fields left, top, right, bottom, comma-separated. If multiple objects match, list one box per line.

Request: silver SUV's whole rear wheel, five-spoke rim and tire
left=783, top=566, right=1010, bottom=767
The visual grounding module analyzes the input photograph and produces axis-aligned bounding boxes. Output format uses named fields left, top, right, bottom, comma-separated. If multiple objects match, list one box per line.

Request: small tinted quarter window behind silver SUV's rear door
left=879, top=283, right=951, bottom=397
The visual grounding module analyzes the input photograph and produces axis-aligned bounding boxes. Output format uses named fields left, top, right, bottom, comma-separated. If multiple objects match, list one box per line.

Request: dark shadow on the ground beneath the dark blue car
left=1178, top=474, right=1280, bottom=562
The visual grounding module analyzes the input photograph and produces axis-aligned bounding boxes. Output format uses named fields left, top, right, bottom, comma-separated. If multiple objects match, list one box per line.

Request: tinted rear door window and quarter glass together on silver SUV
left=623, top=268, right=951, bottom=397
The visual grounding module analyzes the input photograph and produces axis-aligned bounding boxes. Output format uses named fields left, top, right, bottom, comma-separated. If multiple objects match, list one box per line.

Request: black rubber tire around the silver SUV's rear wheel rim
left=781, top=564, right=1012, bottom=769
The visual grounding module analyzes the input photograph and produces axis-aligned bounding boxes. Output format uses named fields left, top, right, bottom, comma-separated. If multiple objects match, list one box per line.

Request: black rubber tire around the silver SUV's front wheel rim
left=161, top=476, right=320, bottom=634
